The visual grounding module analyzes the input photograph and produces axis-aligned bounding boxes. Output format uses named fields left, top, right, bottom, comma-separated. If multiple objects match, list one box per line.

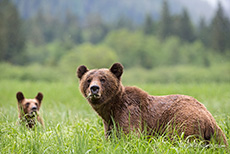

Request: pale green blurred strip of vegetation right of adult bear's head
left=123, top=63, right=230, bottom=84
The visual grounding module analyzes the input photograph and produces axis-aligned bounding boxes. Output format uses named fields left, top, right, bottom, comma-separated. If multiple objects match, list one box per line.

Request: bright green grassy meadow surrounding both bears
left=0, top=79, right=230, bottom=154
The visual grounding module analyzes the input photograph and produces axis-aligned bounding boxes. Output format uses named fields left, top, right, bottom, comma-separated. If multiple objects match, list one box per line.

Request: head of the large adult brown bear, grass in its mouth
left=77, top=63, right=123, bottom=106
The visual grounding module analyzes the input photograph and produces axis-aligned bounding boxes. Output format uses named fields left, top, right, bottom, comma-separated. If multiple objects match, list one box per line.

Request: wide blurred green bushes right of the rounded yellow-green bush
left=105, top=30, right=228, bottom=69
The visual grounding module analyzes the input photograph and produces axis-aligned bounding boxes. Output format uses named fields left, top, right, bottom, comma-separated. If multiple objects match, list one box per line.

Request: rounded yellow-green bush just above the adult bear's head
left=60, top=44, right=117, bottom=73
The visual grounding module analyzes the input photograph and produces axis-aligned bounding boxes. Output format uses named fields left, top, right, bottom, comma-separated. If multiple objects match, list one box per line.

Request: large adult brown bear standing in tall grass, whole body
left=77, top=63, right=228, bottom=146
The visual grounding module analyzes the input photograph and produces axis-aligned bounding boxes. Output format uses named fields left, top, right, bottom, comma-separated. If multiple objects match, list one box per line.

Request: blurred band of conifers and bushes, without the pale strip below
left=0, top=0, right=230, bottom=68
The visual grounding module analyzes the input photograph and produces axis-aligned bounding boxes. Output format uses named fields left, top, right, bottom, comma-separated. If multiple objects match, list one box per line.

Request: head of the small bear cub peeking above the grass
left=16, top=92, right=43, bottom=118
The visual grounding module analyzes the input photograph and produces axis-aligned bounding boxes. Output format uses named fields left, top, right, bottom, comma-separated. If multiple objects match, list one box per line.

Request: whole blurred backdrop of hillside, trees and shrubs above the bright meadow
left=0, top=0, right=230, bottom=83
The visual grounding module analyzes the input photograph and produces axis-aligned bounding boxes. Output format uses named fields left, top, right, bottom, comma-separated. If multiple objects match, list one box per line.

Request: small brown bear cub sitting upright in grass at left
left=16, top=92, right=44, bottom=128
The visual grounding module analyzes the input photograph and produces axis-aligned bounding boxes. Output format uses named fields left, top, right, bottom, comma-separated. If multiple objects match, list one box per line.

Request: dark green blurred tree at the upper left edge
left=0, top=0, right=25, bottom=64
